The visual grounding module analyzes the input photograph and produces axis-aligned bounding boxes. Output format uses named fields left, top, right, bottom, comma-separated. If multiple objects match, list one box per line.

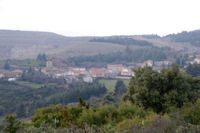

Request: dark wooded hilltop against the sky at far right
left=166, top=30, right=200, bottom=46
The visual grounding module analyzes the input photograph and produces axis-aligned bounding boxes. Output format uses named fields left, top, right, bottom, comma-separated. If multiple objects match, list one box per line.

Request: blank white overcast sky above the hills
left=0, top=0, right=200, bottom=36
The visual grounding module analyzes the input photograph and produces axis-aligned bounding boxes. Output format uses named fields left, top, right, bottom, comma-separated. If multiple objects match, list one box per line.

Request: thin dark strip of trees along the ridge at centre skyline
left=90, top=36, right=153, bottom=46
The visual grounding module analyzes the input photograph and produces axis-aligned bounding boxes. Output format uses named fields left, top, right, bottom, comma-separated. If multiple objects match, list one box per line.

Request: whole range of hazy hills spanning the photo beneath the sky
left=0, top=30, right=200, bottom=60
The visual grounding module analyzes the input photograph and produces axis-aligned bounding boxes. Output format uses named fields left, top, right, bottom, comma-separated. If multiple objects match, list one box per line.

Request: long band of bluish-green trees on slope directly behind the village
left=68, top=47, right=170, bottom=65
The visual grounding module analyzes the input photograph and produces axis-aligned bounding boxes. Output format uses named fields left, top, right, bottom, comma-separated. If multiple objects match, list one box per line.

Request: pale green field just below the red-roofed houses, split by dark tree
left=99, top=79, right=129, bottom=92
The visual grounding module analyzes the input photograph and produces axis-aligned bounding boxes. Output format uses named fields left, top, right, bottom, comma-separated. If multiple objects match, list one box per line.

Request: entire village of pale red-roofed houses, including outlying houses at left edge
left=0, top=56, right=177, bottom=83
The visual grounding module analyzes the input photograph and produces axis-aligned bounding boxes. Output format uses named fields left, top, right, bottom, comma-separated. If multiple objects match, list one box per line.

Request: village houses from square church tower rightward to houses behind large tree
left=41, top=60, right=171, bottom=82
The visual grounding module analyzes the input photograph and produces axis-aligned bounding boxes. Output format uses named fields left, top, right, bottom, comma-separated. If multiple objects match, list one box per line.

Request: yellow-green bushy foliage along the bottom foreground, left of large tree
left=32, top=105, right=150, bottom=128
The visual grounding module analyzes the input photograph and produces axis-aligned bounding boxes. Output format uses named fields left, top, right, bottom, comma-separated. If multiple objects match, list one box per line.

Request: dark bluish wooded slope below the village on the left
left=0, top=80, right=107, bottom=117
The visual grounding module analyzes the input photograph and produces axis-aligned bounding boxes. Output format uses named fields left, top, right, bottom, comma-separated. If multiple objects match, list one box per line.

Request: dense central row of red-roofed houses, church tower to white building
left=41, top=61, right=134, bottom=82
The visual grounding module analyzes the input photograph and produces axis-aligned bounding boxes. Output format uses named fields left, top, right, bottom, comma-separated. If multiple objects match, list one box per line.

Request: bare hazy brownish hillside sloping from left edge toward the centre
left=0, top=30, right=152, bottom=60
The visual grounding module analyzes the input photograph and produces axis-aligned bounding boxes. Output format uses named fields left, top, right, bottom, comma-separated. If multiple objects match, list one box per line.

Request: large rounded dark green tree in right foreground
left=124, top=65, right=200, bottom=113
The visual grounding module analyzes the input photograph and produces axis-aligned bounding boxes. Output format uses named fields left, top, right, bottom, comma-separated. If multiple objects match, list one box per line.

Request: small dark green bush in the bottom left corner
left=5, top=115, right=20, bottom=133
